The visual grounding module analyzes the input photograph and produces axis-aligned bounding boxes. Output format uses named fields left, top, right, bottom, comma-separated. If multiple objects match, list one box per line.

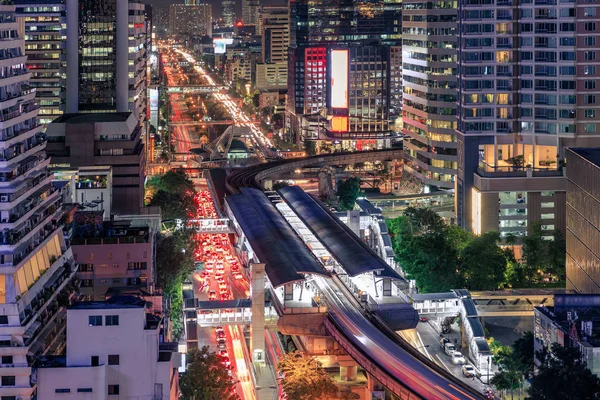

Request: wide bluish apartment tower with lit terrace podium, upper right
left=456, top=0, right=600, bottom=236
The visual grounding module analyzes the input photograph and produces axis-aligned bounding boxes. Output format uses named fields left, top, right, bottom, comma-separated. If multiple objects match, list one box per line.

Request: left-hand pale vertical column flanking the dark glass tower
left=65, top=0, right=79, bottom=114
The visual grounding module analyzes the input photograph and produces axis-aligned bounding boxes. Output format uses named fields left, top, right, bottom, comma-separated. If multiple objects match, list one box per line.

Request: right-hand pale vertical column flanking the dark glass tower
left=116, top=0, right=133, bottom=112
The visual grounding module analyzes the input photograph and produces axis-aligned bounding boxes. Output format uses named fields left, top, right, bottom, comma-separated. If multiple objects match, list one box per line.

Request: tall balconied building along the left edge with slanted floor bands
left=0, top=2, right=75, bottom=400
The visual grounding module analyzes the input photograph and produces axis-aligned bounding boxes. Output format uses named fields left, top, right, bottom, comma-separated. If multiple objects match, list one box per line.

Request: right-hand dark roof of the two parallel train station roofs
left=278, top=186, right=404, bottom=281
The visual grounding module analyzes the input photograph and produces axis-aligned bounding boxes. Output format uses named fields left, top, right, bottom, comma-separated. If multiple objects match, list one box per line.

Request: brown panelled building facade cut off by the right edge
left=566, top=148, right=600, bottom=294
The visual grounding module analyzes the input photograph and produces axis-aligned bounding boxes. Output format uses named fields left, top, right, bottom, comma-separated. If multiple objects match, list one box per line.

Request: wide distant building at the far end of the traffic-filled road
left=169, top=4, right=212, bottom=36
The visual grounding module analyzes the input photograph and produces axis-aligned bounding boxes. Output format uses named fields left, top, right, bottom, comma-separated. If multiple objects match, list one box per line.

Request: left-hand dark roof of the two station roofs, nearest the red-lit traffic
left=225, top=188, right=329, bottom=287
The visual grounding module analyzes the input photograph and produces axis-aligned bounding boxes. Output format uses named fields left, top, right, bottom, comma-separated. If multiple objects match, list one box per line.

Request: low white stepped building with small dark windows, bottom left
left=38, top=296, right=179, bottom=400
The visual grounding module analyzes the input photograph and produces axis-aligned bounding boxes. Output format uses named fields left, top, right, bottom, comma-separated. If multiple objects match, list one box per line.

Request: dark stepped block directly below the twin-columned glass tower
left=46, top=112, right=146, bottom=214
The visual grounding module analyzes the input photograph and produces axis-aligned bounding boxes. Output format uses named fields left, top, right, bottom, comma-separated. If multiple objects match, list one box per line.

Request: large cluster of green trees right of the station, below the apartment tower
left=387, top=207, right=564, bottom=292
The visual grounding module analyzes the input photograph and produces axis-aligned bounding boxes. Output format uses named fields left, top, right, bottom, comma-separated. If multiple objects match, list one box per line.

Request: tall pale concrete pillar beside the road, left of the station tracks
left=250, top=263, right=265, bottom=364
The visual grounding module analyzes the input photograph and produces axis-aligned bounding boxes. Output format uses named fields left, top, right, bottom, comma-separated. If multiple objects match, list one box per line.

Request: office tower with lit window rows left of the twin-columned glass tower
left=14, top=0, right=66, bottom=125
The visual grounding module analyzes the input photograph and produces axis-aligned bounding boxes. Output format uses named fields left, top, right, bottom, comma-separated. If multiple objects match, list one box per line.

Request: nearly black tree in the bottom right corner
left=527, top=343, right=600, bottom=400
